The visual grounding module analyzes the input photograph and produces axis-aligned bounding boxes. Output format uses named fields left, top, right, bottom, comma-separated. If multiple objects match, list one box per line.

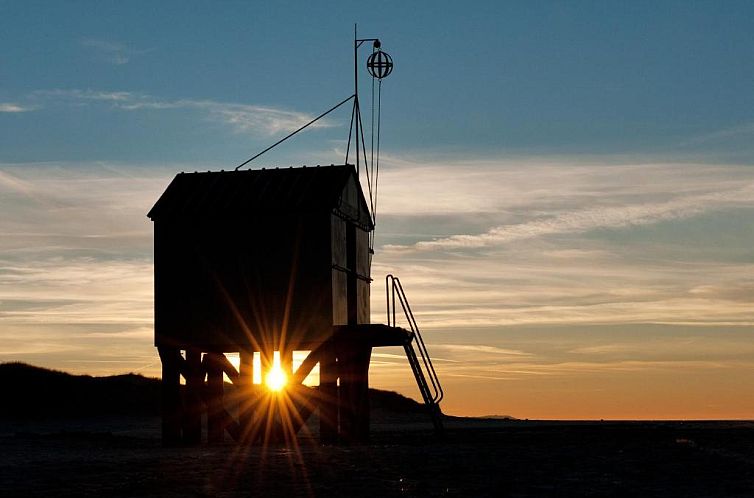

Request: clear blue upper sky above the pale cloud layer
left=5, top=2, right=754, bottom=162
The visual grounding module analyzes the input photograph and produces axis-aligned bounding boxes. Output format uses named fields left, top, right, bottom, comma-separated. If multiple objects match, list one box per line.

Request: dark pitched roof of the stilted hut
left=147, top=164, right=371, bottom=226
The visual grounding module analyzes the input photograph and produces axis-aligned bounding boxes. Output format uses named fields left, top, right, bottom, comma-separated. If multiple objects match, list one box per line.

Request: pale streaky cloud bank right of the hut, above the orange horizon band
left=373, top=158, right=754, bottom=330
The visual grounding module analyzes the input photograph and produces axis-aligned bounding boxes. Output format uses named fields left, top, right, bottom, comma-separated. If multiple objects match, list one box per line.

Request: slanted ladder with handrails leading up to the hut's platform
left=385, top=275, right=445, bottom=435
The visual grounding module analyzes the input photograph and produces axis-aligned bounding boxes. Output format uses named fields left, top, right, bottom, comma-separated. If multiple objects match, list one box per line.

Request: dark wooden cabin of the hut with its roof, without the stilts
left=148, top=166, right=374, bottom=352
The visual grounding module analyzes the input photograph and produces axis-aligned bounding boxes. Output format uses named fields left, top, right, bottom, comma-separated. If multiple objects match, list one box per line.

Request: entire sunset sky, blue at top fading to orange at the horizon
left=0, top=1, right=754, bottom=419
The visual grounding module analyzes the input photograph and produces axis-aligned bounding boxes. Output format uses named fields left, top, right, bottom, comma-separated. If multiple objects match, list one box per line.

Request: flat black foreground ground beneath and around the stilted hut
left=0, top=417, right=754, bottom=498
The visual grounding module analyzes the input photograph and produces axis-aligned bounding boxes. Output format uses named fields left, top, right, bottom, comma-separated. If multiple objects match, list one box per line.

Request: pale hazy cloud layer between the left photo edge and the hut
left=0, top=163, right=170, bottom=374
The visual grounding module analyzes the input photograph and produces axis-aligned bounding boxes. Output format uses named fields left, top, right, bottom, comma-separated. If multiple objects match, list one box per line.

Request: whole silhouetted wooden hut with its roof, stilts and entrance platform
left=148, top=165, right=440, bottom=443
